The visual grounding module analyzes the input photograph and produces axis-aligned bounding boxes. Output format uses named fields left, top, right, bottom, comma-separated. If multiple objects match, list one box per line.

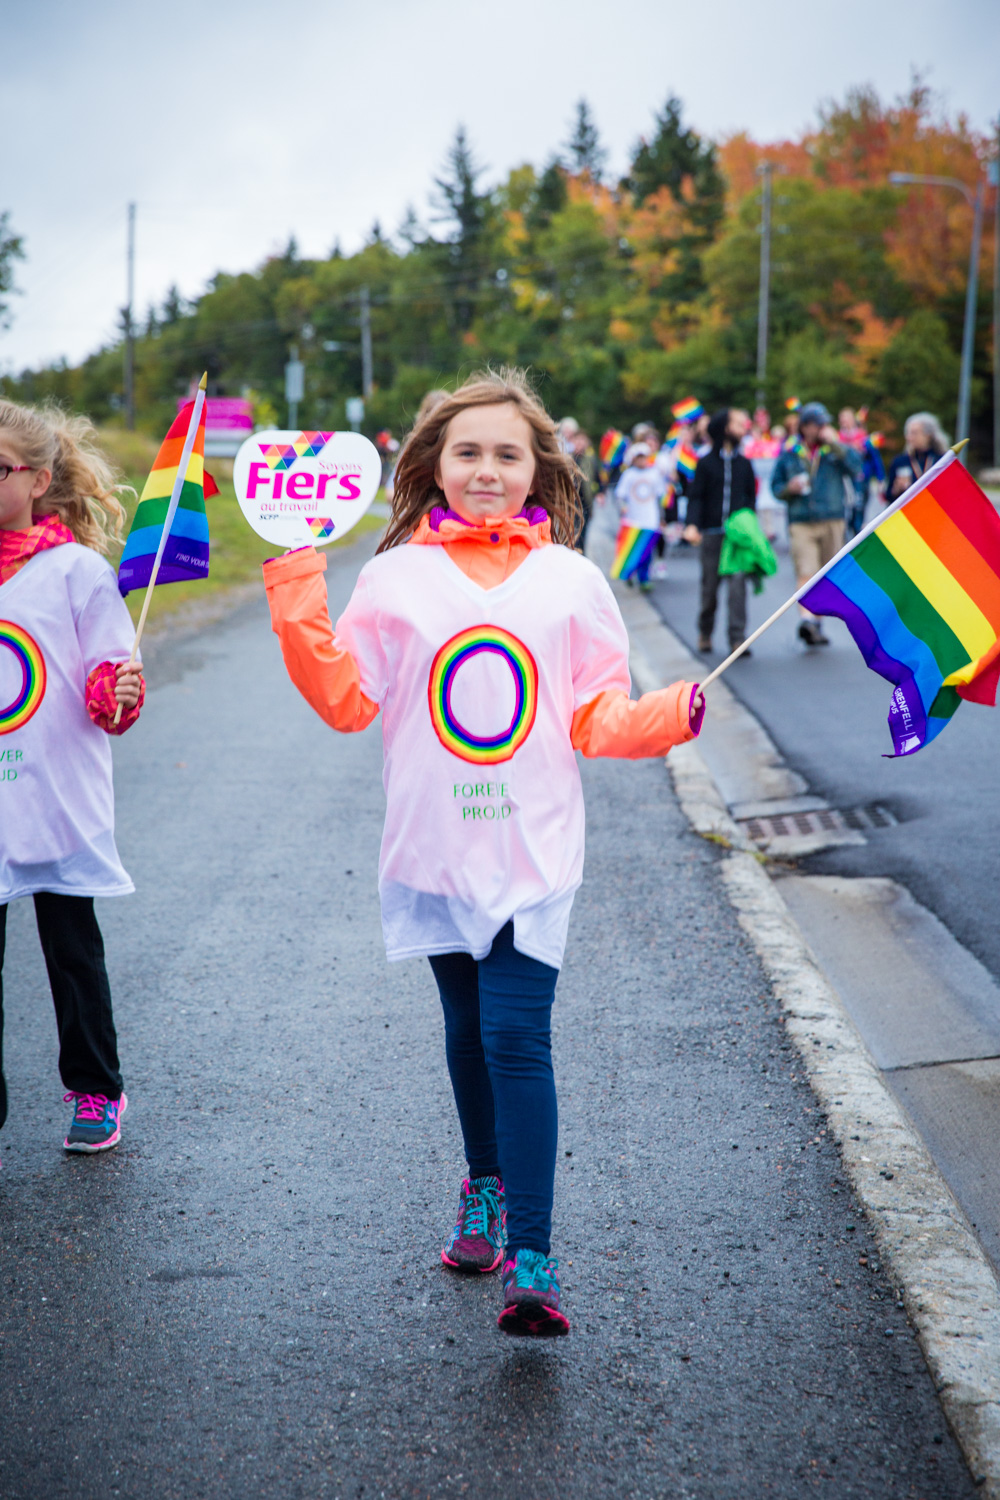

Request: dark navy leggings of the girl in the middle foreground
left=430, top=923, right=559, bottom=1256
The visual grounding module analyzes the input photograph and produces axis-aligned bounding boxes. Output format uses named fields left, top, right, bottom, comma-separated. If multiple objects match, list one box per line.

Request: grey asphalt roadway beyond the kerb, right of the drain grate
left=652, top=531, right=1000, bottom=980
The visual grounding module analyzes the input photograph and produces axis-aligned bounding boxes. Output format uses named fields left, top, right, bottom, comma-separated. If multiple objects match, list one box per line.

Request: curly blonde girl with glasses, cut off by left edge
left=0, top=401, right=145, bottom=1151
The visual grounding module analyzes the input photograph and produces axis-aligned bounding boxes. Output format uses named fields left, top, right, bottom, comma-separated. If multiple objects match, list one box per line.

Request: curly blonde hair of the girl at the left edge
left=0, top=401, right=127, bottom=554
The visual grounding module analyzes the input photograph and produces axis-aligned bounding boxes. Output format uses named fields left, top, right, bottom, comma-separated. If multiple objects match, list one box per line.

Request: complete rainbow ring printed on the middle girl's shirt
left=427, top=626, right=538, bottom=765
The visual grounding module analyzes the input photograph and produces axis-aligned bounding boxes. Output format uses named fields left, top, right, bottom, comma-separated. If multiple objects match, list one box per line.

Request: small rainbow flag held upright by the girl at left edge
left=118, top=399, right=219, bottom=594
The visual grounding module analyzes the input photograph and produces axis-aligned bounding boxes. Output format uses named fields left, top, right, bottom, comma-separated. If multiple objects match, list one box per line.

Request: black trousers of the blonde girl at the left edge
left=0, top=891, right=121, bottom=1125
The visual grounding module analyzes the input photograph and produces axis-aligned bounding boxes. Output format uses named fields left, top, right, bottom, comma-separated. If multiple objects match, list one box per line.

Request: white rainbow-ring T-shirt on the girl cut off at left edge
left=0, top=542, right=135, bottom=903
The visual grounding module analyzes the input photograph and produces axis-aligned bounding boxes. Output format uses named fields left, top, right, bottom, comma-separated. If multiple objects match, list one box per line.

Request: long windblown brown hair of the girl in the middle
left=378, top=368, right=583, bottom=552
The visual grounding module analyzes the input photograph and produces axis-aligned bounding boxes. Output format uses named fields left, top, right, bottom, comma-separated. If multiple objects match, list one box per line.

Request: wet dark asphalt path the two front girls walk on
left=0, top=549, right=978, bottom=1500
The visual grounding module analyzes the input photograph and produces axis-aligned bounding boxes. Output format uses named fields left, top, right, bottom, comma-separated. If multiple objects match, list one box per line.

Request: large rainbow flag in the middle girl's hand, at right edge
left=798, top=453, right=1000, bottom=756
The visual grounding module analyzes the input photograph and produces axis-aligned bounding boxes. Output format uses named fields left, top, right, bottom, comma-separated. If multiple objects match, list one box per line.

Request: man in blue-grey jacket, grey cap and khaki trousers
left=771, top=401, right=864, bottom=647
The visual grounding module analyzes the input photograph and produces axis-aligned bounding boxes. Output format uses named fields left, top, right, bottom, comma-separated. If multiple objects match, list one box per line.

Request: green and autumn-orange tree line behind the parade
left=0, top=80, right=996, bottom=458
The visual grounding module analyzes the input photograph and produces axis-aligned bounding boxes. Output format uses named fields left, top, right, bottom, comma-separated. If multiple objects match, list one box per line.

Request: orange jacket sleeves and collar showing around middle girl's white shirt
left=264, top=515, right=705, bottom=761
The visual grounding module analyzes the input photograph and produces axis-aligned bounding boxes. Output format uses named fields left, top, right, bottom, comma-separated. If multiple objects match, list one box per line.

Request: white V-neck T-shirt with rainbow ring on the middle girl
left=336, top=546, right=630, bottom=968
